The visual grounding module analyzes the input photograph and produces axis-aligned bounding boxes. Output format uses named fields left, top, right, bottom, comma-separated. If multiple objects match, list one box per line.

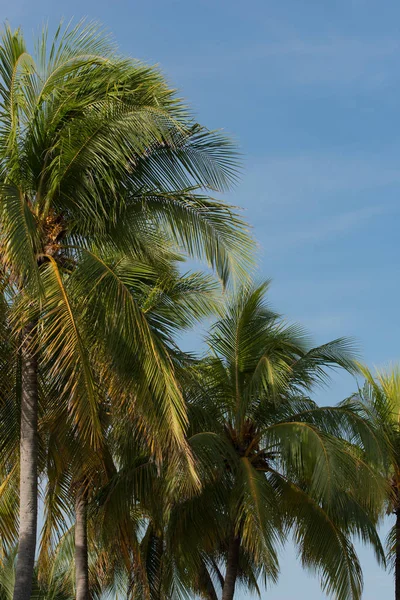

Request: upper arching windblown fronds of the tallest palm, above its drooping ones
left=0, top=23, right=255, bottom=288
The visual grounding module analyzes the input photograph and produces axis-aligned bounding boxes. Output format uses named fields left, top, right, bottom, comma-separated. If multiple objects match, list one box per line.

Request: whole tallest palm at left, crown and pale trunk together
left=0, top=19, right=249, bottom=600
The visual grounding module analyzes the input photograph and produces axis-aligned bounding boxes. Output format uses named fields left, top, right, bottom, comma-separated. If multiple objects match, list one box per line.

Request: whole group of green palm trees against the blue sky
left=0, top=16, right=400, bottom=600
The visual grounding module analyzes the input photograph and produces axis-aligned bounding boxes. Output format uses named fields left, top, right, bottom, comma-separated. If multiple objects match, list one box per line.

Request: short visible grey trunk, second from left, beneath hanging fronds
left=75, top=485, right=90, bottom=600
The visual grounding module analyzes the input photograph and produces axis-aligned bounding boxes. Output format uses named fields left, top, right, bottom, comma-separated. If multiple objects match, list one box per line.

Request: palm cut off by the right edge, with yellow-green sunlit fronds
left=354, top=365, right=400, bottom=600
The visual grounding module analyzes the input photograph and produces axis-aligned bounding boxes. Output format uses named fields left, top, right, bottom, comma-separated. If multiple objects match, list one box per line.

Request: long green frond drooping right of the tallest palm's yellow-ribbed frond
left=72, top=251, right=191, bottom=450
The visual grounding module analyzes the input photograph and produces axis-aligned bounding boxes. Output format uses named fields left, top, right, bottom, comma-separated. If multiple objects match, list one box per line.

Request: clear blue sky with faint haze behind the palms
left=0, top=0, right=400, bottom=600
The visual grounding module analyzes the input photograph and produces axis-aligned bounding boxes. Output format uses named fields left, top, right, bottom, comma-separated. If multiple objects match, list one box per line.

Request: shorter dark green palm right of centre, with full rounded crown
left=180, top=284, right=385, bottom=600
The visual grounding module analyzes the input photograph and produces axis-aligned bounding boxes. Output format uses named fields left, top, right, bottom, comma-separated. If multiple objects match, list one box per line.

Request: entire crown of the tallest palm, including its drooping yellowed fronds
left=0, top=23, right=252, bottom=597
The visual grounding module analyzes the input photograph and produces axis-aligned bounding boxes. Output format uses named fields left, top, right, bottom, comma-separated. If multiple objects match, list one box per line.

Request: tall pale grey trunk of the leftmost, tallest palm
left=13, top=323, right=38, bottom=600
